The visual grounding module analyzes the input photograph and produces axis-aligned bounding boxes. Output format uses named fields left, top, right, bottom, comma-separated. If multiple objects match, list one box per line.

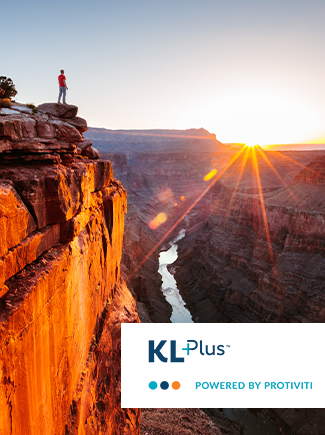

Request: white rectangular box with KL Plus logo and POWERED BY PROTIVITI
left=122, top=323, right=325, bottom=408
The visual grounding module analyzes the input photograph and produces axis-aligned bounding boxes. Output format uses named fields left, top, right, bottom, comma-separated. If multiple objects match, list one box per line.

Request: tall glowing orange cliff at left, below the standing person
left=0, top=105, right=139, bottom=435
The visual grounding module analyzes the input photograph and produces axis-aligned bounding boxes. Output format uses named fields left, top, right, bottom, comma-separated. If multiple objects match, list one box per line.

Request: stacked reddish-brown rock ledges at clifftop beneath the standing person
left=0, top=103, right=95, bottom=163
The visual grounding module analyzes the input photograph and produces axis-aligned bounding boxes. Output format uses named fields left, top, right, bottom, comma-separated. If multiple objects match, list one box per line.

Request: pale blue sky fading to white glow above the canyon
left=0, top=0, right=325, bottom=145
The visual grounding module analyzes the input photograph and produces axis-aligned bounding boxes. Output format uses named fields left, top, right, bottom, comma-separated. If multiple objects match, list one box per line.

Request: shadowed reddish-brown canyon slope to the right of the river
left=176, top=153, right=325, bottom=322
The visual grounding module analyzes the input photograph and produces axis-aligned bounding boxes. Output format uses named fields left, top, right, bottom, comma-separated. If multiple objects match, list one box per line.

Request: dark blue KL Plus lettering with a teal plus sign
left=149, top=340, right=230, bottom=363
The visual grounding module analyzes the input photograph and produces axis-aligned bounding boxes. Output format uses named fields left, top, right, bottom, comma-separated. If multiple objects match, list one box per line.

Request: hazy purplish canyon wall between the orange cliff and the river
left=86, top=128, right=234, bottom=322
